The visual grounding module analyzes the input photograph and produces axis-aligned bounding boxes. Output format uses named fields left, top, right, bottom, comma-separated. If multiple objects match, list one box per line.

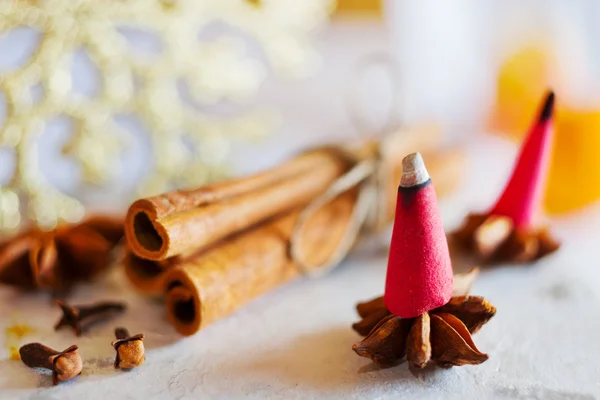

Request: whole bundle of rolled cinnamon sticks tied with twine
left=125, top=127, right=464, bottom=335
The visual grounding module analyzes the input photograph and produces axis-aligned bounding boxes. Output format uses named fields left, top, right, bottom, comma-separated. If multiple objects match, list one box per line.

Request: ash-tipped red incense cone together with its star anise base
left=352, top=153, right=496, bottom=368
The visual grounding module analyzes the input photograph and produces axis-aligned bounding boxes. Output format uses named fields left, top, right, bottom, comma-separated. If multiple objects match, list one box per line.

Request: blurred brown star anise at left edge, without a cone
left=0, top=216, right=123, bottom=291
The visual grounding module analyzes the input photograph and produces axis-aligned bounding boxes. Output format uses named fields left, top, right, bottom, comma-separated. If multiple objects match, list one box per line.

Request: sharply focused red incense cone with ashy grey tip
left=384, top=153, right=453, bottom=318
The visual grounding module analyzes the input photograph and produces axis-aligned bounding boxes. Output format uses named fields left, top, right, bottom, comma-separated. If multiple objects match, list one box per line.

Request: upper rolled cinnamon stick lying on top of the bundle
left=125, top=148, right=349, bottom=260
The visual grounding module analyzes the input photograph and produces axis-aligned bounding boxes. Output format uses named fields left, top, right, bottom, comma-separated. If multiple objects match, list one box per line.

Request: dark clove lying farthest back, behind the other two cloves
left=54, top=300, right=127, bottom=336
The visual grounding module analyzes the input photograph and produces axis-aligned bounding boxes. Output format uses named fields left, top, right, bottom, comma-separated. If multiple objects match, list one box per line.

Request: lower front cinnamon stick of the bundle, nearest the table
left=165, top=190, right=356, bottom=335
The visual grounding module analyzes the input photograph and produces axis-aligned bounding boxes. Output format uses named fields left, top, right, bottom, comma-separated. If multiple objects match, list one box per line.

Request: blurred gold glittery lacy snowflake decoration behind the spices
left=0, top=0, right=333, bottom=230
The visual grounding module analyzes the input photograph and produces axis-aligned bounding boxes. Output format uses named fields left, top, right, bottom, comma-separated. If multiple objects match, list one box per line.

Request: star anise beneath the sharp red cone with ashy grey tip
left=352, top=271, right=496, bottom=368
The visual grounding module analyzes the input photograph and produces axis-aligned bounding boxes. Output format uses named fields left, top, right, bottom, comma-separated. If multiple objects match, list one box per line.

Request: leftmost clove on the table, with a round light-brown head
left=19, top=343, right=83, bottom=385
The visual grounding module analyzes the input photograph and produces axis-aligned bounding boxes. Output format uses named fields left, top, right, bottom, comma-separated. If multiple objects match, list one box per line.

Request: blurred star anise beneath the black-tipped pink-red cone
left=453, top=214, right=560, bottom=263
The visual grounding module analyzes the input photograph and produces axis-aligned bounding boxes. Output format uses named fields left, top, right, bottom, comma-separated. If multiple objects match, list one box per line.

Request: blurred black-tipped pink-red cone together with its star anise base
left=453, top=92, right=560, bottom=263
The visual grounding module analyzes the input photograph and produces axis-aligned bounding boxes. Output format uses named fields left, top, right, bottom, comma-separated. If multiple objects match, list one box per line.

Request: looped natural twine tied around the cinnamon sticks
left=290, top=145, right=386, bottom=278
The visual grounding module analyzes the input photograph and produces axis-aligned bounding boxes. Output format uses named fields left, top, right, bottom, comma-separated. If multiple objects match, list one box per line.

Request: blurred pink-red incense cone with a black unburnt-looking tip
left=490, top=92, right=554, bottom=228
